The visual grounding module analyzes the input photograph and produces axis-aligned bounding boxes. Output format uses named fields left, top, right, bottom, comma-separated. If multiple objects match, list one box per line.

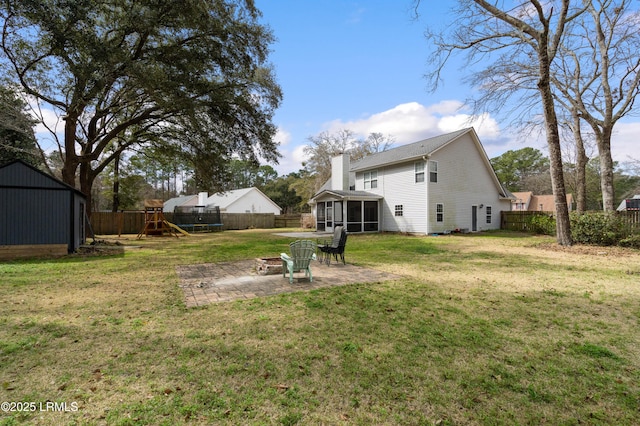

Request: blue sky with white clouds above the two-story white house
left=255, top=0, right=640, bottom=175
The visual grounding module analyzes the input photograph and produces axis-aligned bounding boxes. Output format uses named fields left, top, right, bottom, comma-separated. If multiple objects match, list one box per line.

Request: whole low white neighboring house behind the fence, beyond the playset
left=163, top=187, right=282, bottom=215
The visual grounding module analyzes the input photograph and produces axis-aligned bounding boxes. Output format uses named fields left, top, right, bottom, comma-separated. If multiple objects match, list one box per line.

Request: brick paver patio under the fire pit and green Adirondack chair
left=176, top=259, right=400, bottom=308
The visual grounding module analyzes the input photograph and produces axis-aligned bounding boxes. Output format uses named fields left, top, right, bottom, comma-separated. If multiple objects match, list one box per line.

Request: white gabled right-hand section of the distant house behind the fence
left=205, top=187, right=282, bottom=216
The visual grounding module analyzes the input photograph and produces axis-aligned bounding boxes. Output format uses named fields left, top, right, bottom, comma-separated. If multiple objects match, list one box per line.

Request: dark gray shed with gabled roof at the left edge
left=0, top=160, right=86, bottom=259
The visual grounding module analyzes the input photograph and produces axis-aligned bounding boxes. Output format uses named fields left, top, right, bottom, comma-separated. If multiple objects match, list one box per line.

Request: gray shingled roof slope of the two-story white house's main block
left=351, top=127, right=470, bottom=172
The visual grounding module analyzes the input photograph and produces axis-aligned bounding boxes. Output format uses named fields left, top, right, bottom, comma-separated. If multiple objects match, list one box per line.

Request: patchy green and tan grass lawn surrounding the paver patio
left=0, top=230, right=640, bottom=425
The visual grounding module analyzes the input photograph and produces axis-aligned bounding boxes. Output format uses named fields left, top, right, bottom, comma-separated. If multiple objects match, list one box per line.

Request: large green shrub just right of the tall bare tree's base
left=571, top=212, right=629, bottom=246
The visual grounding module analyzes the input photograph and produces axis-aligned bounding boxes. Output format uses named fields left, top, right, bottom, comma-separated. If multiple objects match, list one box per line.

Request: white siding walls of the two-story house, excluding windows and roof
left=355, top=133, right=511, bottom=234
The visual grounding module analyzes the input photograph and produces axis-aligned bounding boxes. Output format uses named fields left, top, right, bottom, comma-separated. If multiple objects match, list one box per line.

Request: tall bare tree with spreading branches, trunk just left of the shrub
left=428, top=0, right=584, bottom=245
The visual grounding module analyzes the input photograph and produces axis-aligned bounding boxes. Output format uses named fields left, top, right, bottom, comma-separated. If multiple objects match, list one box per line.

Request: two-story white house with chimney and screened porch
left=309, top=128, right=512, bottom=234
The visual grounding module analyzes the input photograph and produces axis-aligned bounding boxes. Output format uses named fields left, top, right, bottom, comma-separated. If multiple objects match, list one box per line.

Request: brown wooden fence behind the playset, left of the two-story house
left=91, top=211, right=292, bottom=235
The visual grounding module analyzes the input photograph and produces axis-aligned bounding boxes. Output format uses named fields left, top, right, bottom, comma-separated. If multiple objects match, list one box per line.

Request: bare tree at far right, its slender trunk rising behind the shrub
left=552, top=0, right=640, bottom=211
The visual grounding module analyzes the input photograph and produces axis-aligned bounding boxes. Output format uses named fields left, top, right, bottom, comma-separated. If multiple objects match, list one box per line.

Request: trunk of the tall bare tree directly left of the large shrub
left=538, top=36, right=572, bottom=246
